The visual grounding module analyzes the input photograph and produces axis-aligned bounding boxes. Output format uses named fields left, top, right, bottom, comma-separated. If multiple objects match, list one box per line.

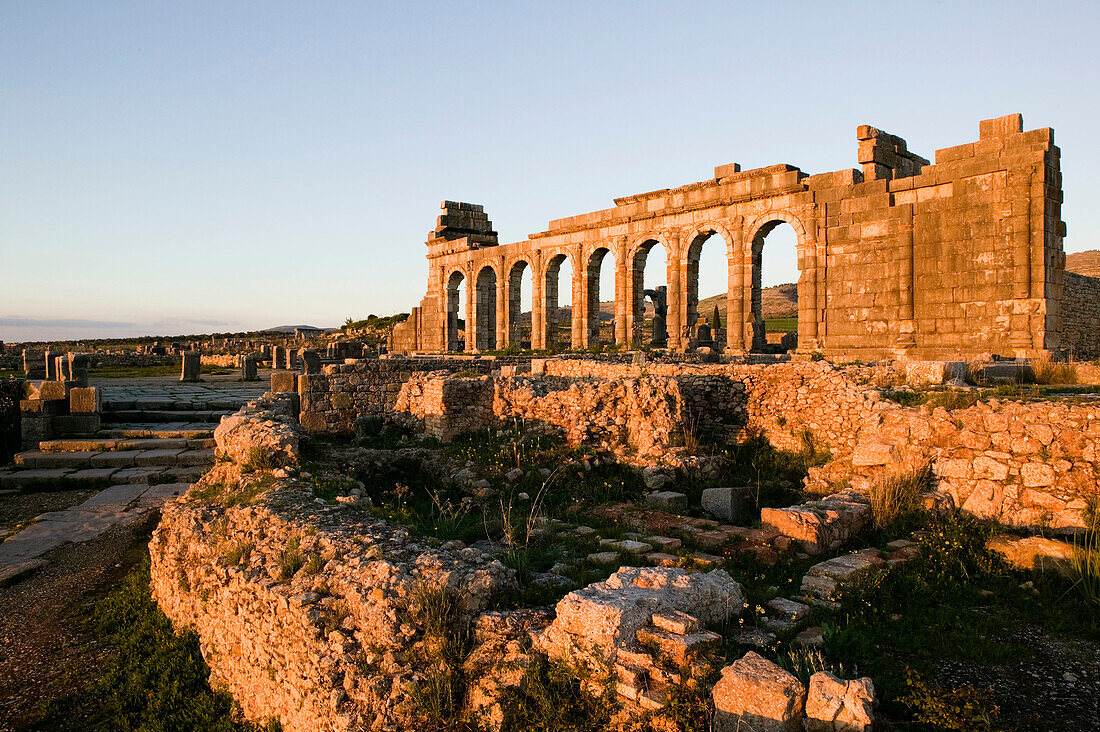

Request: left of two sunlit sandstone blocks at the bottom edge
left=712, top=651, right=806, bottom=732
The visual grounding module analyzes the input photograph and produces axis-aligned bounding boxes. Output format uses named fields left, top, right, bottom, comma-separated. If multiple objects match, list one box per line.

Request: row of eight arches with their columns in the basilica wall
left=446, top=219, right=799, bottom=351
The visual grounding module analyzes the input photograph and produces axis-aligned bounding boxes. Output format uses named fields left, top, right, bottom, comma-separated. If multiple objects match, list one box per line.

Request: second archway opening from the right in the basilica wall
left=683, top=229, right=730, bottom=350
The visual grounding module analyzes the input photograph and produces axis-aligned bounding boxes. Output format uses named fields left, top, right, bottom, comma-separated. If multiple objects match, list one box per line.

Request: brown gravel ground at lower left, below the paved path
left=0, top=511, right=160, bottom=732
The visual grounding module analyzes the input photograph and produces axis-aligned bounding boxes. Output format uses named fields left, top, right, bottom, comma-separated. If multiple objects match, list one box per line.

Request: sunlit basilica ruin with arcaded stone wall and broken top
left=391, top=114, right=1100, bottom=360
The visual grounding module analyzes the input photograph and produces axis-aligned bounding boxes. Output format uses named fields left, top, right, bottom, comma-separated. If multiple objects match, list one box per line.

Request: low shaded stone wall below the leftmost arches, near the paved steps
left=298, top=358, right=496, bottom=433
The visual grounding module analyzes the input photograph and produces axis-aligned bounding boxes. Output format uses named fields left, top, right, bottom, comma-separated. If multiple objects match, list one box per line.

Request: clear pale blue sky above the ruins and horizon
left=0, top=0, right=1100, bottom=342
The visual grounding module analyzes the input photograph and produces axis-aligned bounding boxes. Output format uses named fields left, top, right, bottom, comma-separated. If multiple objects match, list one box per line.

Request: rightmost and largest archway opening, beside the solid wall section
left=751, top=220, right=799, bottom=353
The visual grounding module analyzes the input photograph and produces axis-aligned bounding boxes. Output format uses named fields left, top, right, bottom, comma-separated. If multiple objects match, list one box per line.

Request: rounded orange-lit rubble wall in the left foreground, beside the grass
left=150, top=395, right=517, bottom=732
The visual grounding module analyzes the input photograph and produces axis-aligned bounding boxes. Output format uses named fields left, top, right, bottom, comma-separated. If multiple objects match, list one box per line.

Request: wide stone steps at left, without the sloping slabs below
left=0, top=398, right=227, bottom=491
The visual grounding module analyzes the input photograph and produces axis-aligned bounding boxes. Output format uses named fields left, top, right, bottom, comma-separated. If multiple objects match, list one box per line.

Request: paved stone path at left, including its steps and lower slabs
left=0, top=376, right=267, bottom=583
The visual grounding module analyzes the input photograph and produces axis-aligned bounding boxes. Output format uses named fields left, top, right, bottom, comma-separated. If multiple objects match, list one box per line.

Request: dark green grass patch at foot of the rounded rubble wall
left=29, top=558, right=264, bottom=732
